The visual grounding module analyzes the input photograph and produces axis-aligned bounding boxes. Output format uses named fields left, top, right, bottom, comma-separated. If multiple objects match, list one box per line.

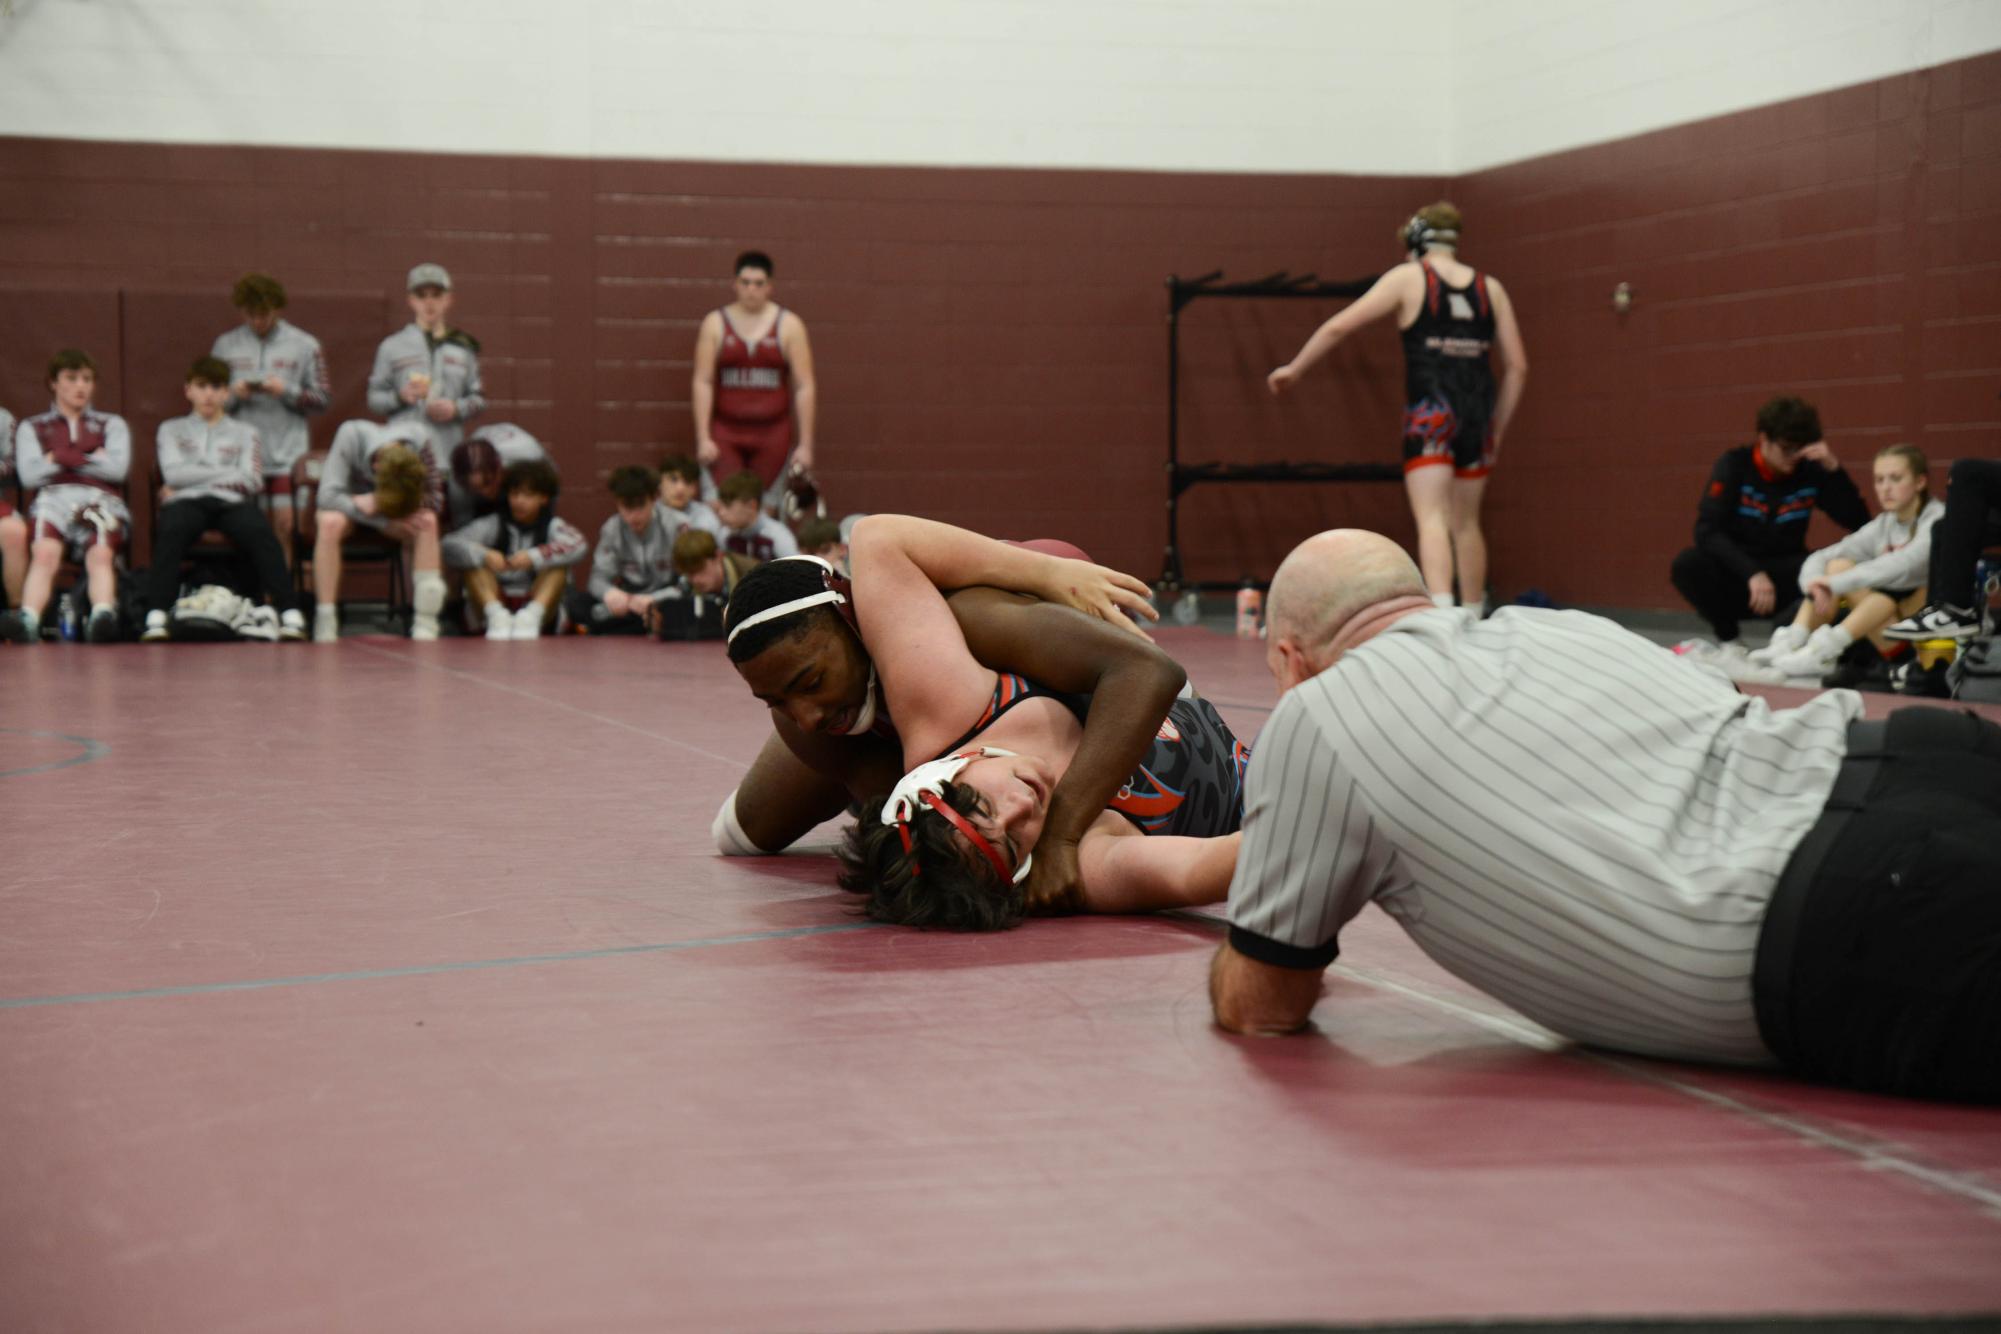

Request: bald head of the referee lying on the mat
left=1265, top=528, right=1431, bottom=686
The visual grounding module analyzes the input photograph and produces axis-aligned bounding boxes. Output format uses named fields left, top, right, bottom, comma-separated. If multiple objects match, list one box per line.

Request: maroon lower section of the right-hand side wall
left=1453, top=54, right=2001, bottom=606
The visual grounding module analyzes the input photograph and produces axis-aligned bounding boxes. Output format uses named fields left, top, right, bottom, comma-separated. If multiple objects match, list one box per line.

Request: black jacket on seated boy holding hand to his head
left=1695, top=444, right=1869, bottom=580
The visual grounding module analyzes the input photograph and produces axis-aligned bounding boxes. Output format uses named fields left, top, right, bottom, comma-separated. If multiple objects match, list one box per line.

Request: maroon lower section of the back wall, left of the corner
left=0, top=138, right=1443, bottom=578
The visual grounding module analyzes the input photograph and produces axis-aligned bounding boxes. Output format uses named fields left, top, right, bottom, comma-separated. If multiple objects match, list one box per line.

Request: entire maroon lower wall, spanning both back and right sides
left=0, top=45, right=2001, bottom=606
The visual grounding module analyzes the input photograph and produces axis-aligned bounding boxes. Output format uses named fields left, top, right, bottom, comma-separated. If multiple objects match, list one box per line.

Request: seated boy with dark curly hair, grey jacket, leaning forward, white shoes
left=444, top=458, right=586, bottom=640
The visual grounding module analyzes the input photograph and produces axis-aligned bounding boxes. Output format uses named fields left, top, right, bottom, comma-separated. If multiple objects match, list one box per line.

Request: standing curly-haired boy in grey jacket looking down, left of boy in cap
left=208, top=274, right=334, bottom=560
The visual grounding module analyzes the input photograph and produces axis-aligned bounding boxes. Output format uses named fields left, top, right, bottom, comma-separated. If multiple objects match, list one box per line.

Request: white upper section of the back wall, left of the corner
left=0, top=0, right=1449, bottom=174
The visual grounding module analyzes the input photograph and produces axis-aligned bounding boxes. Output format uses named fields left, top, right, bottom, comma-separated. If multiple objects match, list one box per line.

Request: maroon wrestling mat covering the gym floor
left=0, top=630, right=2001, bottom=1332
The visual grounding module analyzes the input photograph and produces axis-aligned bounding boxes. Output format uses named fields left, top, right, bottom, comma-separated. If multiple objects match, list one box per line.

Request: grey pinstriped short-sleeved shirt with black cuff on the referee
left=1229, top=608, right=1861, bottom=1062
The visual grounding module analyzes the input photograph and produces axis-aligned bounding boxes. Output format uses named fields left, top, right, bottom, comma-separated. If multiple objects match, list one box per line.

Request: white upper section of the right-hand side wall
left=1447, top=0, right=2001, bottom=174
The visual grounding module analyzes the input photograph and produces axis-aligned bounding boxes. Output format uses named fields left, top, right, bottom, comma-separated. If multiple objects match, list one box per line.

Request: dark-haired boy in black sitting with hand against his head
left=1673, top=398, right=1869, bottom=672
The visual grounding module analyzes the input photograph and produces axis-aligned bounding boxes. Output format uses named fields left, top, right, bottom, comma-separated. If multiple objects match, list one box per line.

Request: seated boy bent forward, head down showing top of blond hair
left=312, top=420, right=444, bottom=644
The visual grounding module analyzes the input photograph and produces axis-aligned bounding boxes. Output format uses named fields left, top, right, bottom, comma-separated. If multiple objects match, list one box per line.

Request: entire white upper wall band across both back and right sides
left=0, top=0, right=2001, bottom=176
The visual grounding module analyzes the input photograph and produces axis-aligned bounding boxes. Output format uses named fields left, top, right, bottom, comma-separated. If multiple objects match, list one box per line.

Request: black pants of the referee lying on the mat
left=1755, top=708, right=2001, bottom=1102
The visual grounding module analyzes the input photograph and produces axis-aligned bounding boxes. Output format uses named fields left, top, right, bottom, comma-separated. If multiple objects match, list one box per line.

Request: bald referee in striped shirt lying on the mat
left=1211, top=530, right=2001, bottom=1102
